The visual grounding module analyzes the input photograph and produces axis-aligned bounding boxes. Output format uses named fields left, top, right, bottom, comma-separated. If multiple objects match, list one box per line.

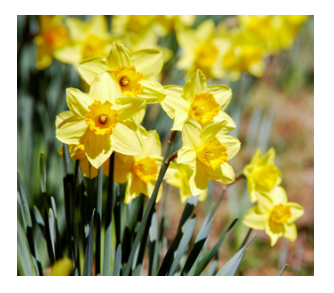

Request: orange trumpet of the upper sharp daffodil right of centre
left=189, top=93, right=219, bottom=123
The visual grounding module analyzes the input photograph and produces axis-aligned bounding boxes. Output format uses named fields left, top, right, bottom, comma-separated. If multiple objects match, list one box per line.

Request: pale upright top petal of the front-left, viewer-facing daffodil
left=89, top=72, right=122, bottom=105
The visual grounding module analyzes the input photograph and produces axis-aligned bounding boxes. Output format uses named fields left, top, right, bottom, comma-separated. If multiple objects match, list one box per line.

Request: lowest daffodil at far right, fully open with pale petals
left=242, top=186, right=304, bottom=246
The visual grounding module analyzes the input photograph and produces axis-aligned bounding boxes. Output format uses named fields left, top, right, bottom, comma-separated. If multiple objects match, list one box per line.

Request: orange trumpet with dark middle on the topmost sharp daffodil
left=113, top=65, right=144, bottom=97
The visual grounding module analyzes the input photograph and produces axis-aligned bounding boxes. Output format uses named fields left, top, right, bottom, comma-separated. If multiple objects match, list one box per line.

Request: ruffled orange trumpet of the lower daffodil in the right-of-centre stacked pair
left=197, top=140, right=227, bottom=170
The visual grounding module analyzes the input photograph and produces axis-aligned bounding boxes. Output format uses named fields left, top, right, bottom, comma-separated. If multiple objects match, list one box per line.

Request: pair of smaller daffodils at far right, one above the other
left=242, top=148, right=304, bottom=246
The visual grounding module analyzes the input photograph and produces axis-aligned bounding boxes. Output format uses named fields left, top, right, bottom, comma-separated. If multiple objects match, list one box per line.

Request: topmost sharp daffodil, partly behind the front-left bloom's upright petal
left=78, top=42, right=166, bottom=123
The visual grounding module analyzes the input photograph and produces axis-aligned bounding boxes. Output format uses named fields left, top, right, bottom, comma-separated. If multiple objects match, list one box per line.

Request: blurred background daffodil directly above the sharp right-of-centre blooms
left=176, top=19, right=225, bottom=78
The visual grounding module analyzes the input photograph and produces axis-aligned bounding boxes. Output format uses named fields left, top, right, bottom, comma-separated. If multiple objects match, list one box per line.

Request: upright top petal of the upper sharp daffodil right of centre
left=183, top=69, right=207, bottom=103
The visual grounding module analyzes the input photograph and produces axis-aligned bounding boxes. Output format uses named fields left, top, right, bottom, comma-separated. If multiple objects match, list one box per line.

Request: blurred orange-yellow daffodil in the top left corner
left=34, top=15, right=69, bottom=70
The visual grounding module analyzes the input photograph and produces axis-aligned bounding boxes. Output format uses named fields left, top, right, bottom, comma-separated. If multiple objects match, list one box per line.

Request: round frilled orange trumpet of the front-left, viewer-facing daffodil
left=85, top=100, right=119, bottom=135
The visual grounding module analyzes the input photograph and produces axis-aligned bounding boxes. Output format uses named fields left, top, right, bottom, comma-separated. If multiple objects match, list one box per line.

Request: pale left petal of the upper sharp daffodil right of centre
left=160, top=85, right=190, bottom=119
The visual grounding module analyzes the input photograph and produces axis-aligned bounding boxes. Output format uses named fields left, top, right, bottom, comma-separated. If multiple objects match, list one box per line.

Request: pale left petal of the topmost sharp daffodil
left=77, top=58, right=108, bottom=85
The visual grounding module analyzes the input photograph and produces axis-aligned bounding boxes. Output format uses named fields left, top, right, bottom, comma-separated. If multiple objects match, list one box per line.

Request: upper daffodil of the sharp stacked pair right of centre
left=160, top=70, right=236, bottom=131
